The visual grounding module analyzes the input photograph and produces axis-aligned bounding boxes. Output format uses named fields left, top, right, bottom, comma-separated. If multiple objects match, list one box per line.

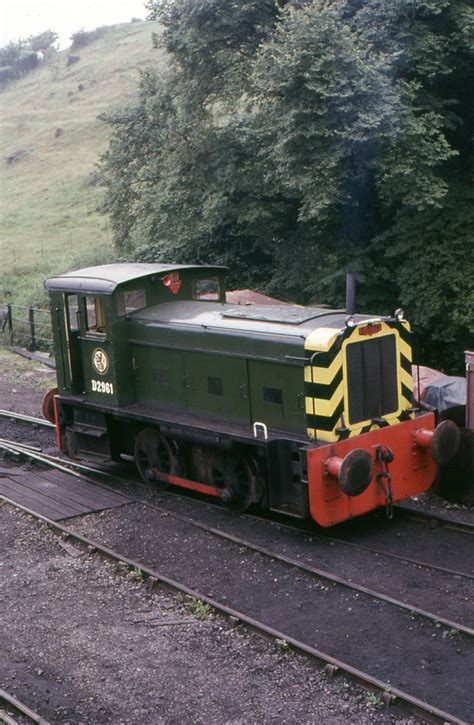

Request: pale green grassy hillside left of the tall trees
left=0, top=22, right=164, bottom=302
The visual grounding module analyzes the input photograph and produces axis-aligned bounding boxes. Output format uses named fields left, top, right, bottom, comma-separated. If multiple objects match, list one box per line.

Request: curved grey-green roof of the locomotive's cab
left=44, top=262, right=227, bottom=295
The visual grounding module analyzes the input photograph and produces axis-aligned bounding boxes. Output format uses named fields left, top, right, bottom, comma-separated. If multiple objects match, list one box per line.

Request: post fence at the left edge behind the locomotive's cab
left=0, top=302, right=53, bottom=352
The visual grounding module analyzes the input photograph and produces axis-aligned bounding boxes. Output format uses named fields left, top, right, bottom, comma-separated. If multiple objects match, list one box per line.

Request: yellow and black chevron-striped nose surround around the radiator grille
left=305, top=319, right=413, bottom=442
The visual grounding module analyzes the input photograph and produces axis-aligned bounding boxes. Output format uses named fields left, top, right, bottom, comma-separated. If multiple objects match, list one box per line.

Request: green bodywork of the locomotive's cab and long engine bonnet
left=45, top=264, right=378, bottom=436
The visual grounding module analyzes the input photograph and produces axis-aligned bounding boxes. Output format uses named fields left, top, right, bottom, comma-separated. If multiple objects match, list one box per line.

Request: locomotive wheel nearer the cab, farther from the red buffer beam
left=135, top=428, right=182, bottom=489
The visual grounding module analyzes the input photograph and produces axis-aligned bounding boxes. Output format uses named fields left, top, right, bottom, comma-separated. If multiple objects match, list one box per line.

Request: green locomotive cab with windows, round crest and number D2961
left=45, top=264, right=225, bottom=406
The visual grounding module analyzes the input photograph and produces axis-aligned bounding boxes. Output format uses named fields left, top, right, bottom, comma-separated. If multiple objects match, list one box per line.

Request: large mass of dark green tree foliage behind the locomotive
left=99, top=0, right=474, bottom=367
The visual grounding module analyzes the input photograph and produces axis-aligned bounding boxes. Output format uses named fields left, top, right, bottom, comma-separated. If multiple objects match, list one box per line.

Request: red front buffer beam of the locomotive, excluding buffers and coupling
left=308, top=413, right=436, bottom=526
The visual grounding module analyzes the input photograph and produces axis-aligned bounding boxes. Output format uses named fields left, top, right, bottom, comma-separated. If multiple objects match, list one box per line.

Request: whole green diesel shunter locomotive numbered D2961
left=45, top=264, right=451, bottom=526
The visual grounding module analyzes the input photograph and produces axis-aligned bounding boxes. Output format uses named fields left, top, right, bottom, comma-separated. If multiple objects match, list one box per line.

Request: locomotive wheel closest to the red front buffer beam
left=211, top=456, right=261, bottom=513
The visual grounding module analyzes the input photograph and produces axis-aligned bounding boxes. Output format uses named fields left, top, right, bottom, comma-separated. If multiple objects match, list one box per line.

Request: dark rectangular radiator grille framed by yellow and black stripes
left=346, top=335, right=398, bottom=424
